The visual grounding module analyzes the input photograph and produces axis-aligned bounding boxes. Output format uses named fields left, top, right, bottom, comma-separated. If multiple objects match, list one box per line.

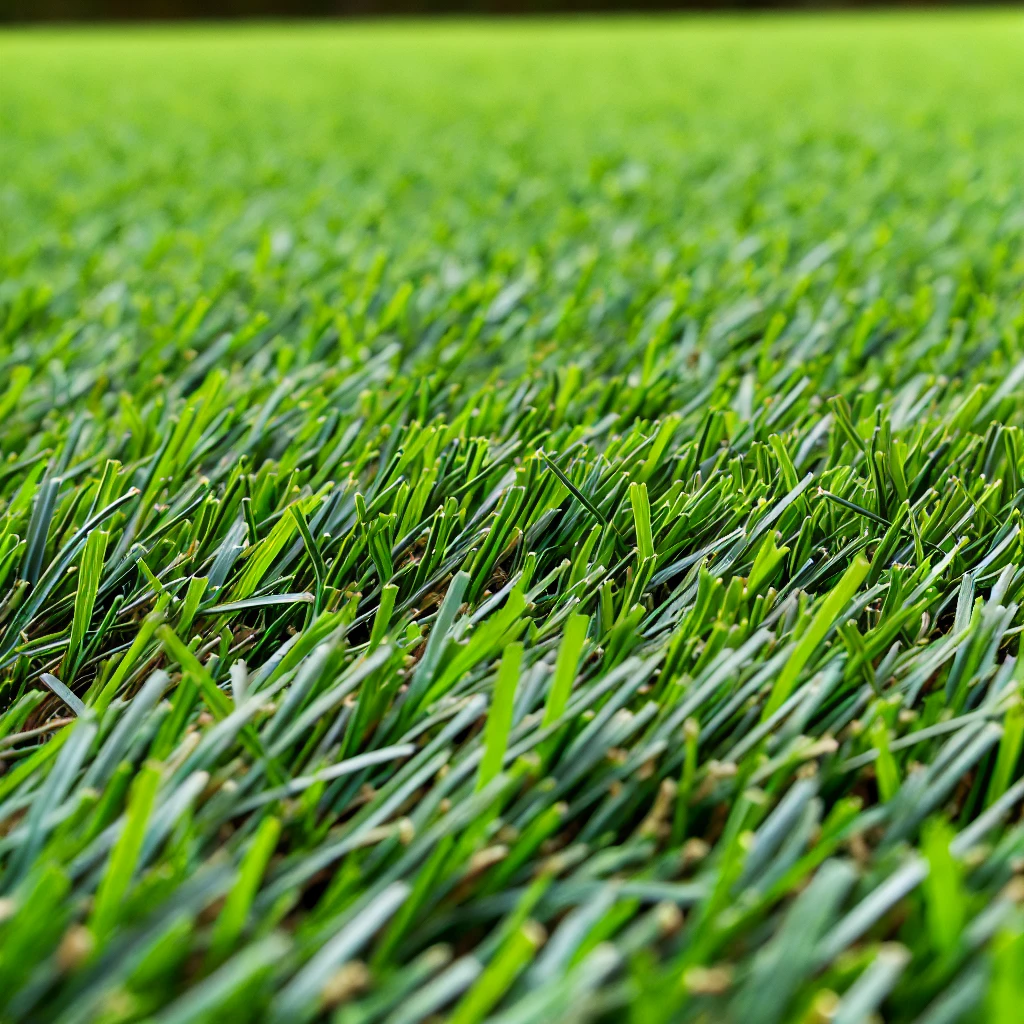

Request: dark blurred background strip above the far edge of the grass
left=0, top=0, right=991, bottom=23
